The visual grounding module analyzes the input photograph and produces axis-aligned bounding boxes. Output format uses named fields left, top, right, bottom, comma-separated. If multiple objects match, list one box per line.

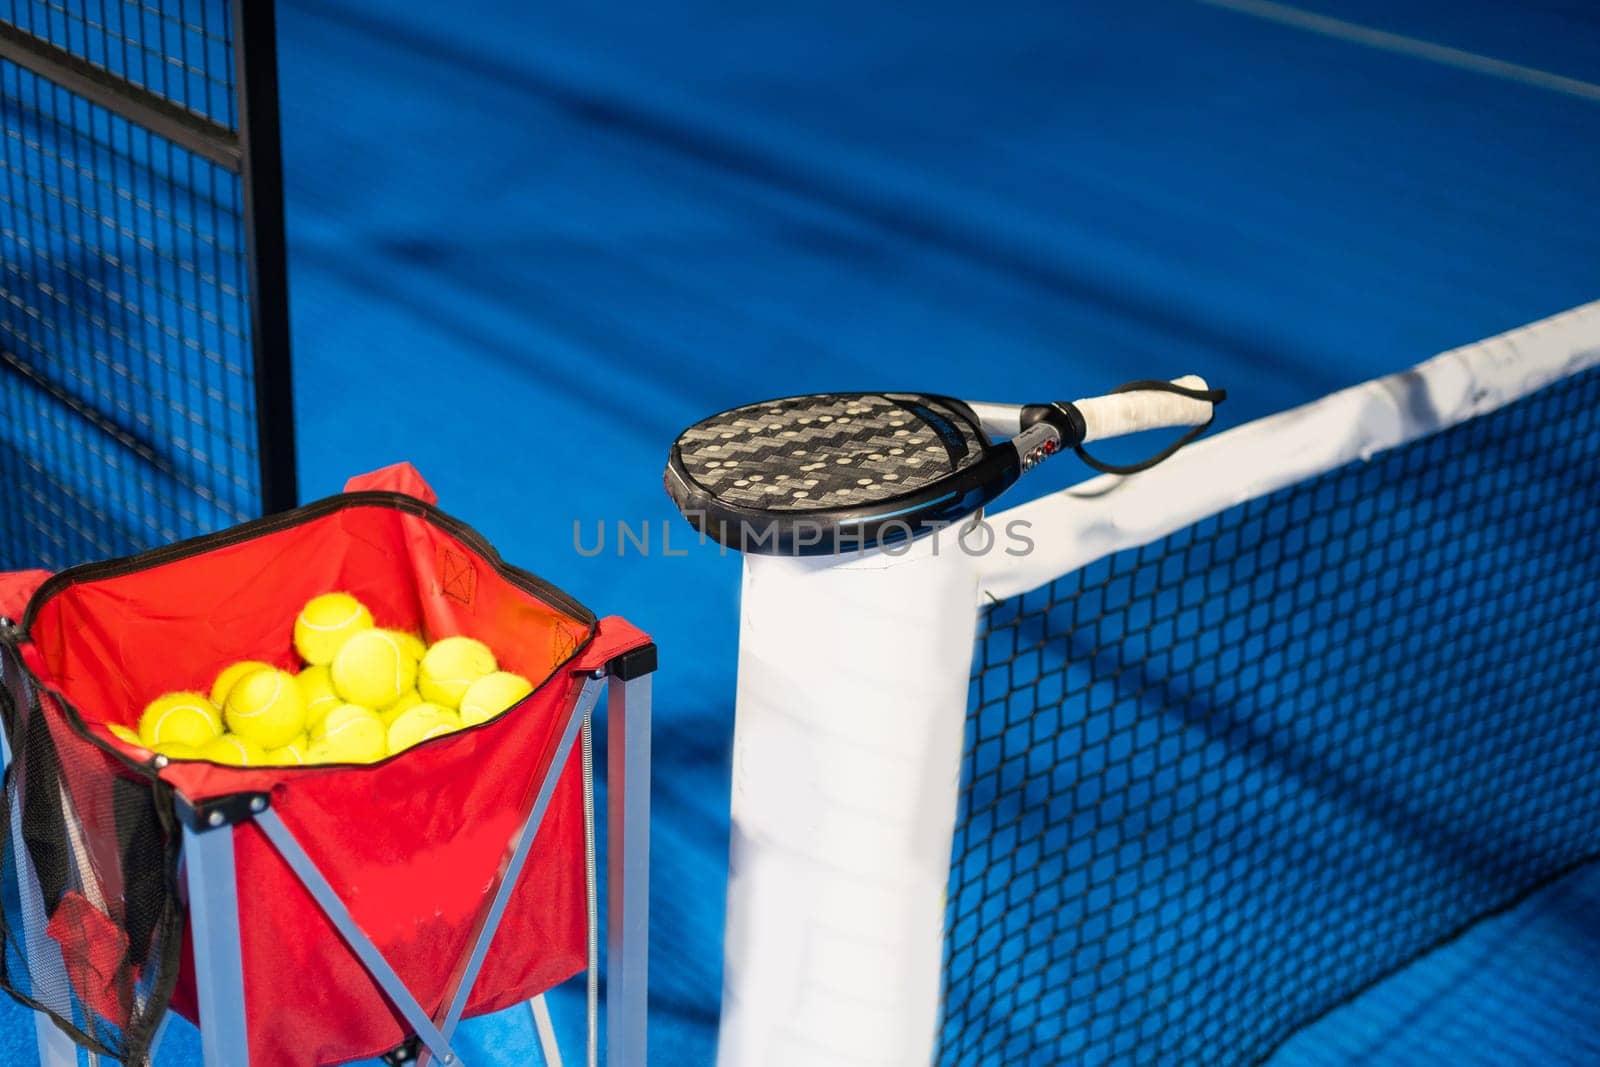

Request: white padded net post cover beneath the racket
left=718, top=528, right=978, bottom=1067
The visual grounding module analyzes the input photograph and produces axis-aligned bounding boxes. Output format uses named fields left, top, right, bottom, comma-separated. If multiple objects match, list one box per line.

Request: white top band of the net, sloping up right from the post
left=979, top=301, right=1600, bottom=601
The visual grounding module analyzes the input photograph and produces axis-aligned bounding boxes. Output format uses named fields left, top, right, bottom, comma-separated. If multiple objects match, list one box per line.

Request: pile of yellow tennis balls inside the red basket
left=123, top=592, right=533, bottom=766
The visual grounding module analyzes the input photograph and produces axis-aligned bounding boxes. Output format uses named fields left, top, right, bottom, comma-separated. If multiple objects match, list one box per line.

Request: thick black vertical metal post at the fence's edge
left=234, top=0, right=299, bottom=515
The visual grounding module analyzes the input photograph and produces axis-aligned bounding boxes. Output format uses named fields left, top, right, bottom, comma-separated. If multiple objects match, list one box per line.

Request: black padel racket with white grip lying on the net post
left=666, top=376, right=1226, bottom=555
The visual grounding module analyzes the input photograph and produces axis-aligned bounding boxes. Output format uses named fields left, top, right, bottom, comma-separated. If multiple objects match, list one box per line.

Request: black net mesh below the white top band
left=939, top=371, right=1600, bottom=1065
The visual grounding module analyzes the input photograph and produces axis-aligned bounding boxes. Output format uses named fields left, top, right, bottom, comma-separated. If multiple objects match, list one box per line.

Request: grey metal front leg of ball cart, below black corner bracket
left=184, top=824, right=250, bottom=1067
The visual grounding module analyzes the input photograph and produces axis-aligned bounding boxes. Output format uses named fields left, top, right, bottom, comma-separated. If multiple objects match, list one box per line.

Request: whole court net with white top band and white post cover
left=723, top=304, right=1600, bottom=1067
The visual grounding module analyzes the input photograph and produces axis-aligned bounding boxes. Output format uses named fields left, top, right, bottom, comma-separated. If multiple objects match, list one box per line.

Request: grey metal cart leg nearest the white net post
left=605, top=646, right=656, bottom=1067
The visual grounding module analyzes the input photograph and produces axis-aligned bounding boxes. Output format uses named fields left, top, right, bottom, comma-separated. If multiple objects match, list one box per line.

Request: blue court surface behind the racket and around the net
left=12, top=0, right=1600, bottom=1067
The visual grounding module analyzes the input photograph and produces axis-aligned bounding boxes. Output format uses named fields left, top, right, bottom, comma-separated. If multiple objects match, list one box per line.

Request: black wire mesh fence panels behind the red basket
left=0, top=0, right=262, bottom=569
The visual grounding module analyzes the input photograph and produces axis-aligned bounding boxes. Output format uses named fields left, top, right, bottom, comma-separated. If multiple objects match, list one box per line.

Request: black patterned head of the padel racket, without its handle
left=666, top=392, right=1019, bottom=555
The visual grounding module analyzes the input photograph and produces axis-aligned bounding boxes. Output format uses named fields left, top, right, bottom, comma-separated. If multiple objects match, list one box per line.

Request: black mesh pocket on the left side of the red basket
left=0, top=641, right=184, bottom=1064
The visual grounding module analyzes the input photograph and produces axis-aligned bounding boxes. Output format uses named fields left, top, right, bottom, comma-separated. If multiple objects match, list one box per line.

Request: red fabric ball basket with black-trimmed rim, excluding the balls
left=0, top=467, right=650, bottom=1067
